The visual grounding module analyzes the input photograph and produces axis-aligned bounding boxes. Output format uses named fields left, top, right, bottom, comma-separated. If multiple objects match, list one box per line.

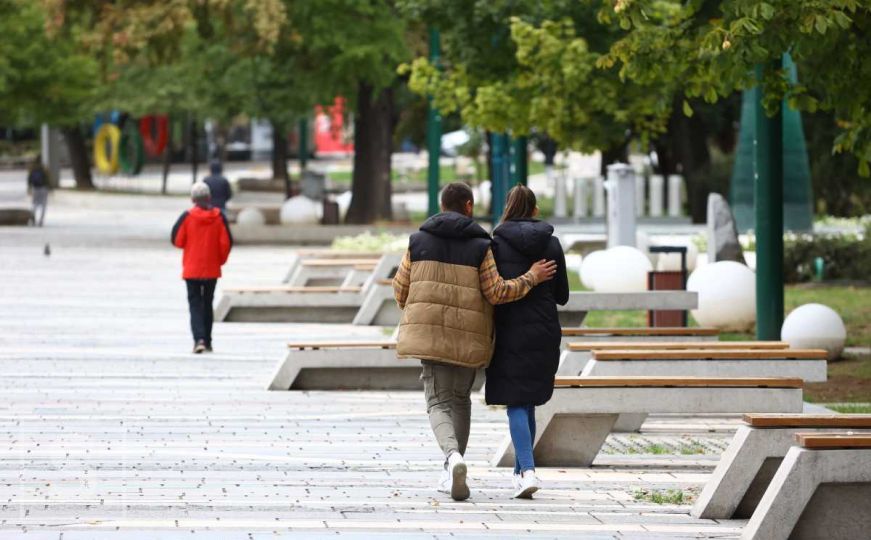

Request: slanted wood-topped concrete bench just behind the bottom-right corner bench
left=692, top=414, right=871, bottom=519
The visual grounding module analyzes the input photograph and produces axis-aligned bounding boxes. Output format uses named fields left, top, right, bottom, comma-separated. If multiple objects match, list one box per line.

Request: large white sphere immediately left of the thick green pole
left=687, top=261, right=756, bottom=331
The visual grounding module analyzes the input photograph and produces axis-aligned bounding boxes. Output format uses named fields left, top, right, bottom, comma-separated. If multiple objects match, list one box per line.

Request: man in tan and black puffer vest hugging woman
left=393, top=182, right=556, bottom=501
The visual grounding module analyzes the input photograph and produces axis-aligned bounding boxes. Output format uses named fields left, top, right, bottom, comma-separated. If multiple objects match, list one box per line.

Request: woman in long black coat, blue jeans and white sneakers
left=485, top=185, right=569, bottom=498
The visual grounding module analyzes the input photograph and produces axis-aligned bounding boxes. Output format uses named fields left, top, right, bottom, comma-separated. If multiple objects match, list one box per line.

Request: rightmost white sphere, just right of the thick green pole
left=780, top=304, right=847, bottom=360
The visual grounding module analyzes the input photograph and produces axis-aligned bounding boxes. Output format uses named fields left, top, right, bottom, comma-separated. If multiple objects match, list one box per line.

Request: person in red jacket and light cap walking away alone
left=172, top=182, right=233, bottom=354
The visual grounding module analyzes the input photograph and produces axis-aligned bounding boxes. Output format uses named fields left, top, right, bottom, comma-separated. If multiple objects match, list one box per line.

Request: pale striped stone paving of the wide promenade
left=0, top=175, right=741, bottom=540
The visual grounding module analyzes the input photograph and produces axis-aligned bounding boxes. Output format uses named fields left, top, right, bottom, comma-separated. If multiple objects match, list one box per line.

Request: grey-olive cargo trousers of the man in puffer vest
left=420, top=360, right=477, bottom=458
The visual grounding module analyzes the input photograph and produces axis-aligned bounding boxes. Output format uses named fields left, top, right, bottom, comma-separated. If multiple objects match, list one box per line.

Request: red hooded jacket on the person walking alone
left=172, top=206, right=233, bottom=279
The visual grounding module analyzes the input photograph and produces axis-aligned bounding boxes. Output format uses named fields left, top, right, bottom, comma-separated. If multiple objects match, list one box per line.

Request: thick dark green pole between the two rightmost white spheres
left=754, top=60, right=783, bottom=340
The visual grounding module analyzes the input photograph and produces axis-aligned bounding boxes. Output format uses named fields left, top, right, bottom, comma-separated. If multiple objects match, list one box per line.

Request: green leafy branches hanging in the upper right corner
left=599, top=0, right=871, bottom=175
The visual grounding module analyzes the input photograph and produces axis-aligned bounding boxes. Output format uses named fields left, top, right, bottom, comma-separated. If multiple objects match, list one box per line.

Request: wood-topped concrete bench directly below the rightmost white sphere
left=576, top=348, right=828, bottom=432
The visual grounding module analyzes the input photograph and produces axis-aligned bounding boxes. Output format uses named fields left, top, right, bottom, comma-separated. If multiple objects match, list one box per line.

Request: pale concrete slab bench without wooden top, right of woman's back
left=557, top=291, right=699, bottom=326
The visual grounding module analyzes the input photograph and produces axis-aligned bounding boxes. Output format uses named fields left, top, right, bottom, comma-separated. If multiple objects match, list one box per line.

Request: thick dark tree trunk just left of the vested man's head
left=345, top=83, right=393, bottom=224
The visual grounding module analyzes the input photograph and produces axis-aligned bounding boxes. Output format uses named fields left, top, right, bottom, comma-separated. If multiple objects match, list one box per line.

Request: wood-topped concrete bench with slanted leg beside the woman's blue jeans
left=492, top=377, right=802, bottom=467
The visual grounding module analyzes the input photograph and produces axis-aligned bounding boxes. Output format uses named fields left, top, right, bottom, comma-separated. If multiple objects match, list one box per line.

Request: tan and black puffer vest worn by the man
left=396, top=212, right=493, bottom=368
